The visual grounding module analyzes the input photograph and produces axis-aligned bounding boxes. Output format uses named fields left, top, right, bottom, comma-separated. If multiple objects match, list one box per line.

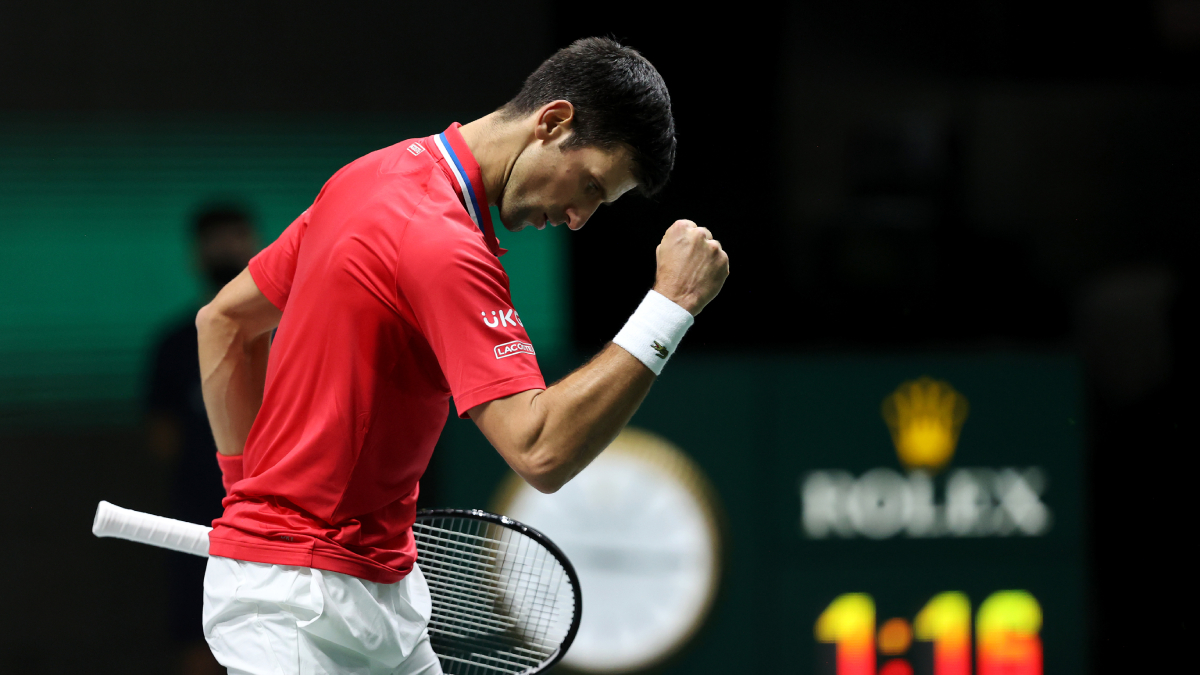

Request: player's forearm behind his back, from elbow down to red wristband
left=196, top=307, right=270, bottom=455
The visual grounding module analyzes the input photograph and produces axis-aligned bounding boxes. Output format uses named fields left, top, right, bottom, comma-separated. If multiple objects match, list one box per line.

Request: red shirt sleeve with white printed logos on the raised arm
left=396, top=210, right=546, bottom=417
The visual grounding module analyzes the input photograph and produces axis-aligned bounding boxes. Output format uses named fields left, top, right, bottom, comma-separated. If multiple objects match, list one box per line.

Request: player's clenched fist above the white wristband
left=654, top=220, right=730, bottom=316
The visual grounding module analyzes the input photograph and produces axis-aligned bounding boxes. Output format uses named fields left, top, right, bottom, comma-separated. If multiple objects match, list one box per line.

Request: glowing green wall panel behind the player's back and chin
left=0, top=114, right=569, bottom=428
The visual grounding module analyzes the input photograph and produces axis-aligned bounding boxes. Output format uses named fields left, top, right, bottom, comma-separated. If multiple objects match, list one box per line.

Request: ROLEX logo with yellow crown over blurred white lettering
left=799, top=377, right=1051, bottom=539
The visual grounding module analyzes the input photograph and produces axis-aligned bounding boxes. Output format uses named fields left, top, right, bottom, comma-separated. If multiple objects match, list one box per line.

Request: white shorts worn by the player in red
left=204, top=557, right=442, bottom=675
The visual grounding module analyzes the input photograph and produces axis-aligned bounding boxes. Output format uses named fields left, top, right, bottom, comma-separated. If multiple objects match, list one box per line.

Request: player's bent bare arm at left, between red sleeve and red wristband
left=196, top=269, right=283, bottom=456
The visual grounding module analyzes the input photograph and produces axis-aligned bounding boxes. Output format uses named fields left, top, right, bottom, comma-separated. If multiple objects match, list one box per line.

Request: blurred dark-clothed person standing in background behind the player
left=145, top=204, right=259, bottom=675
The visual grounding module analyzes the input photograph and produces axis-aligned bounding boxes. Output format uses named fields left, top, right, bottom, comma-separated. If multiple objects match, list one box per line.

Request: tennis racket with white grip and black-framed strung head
left=91, top=502, right=583, bottom=675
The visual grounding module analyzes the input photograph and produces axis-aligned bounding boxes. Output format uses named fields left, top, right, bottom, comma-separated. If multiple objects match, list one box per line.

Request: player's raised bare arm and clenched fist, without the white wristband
left=468, top=221, right=730, bottom=492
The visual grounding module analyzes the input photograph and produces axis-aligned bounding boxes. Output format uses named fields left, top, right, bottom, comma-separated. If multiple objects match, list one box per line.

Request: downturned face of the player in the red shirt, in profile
left=497, top=135, right=637, bottom=232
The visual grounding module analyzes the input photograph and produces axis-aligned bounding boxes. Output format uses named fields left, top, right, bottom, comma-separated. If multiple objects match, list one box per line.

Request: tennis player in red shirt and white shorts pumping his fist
left=196, top=38, right=728, bottom=675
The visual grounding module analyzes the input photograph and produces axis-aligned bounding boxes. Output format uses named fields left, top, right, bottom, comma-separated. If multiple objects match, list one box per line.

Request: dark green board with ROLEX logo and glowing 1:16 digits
left=778, top=357, right=1085, bottom=675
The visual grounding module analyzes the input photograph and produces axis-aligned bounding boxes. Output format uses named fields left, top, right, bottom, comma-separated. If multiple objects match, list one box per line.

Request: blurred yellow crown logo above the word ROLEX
left=883, top=377, right=968, bottom=471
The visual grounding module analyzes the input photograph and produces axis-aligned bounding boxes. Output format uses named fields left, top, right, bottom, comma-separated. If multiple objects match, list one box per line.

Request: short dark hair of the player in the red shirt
left=500, top=37, right=676, bottom=196
